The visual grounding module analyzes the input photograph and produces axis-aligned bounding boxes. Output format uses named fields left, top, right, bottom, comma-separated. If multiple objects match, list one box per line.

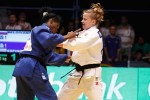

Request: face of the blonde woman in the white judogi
left=81, top=13, right=96, bottom=30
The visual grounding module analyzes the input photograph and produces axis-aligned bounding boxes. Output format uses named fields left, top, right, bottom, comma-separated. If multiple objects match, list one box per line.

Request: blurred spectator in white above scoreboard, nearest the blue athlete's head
left=18, top=12, right=31, bottom=30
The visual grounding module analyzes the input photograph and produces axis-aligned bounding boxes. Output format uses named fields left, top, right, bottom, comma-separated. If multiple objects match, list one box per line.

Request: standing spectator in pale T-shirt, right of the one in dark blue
left=117, top=16, right=135, bottom=61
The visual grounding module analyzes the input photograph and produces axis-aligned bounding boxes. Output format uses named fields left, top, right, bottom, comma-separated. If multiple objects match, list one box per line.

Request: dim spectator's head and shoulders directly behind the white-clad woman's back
left=100, top=19, right=110, bottom=38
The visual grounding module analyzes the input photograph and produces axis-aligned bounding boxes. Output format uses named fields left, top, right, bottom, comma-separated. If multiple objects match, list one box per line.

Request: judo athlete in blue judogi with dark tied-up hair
left=13, top=12, right=76, bottom=100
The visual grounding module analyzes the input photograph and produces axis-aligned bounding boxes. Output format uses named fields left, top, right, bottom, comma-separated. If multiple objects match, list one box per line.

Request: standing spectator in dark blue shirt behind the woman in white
left=104, top=25, right=121, bottom=66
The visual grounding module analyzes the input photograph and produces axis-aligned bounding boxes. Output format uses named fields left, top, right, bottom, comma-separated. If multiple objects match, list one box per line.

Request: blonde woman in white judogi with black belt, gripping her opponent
left=58, top=3, right=104, bottom=100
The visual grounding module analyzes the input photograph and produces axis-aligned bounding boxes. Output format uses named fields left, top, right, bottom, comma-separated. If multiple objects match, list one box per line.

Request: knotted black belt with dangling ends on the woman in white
left=61, top=62, right=100, bottom=84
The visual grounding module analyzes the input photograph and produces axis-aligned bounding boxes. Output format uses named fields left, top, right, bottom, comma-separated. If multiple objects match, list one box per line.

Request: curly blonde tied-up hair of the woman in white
left=83, top=3, right=104, bottom=25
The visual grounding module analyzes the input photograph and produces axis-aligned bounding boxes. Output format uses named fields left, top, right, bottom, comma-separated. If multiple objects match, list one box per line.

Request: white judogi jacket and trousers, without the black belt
left=58, top=26, right=103, bottom=100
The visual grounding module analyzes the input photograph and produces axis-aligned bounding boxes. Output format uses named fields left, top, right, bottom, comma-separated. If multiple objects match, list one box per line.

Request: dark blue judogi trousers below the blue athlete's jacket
left=16, top=64, right=58, bottom=100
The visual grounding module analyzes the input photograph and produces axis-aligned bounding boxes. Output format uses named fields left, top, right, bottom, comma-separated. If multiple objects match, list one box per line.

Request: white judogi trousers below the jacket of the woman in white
left=58, top=76, right=102, bottom=100
